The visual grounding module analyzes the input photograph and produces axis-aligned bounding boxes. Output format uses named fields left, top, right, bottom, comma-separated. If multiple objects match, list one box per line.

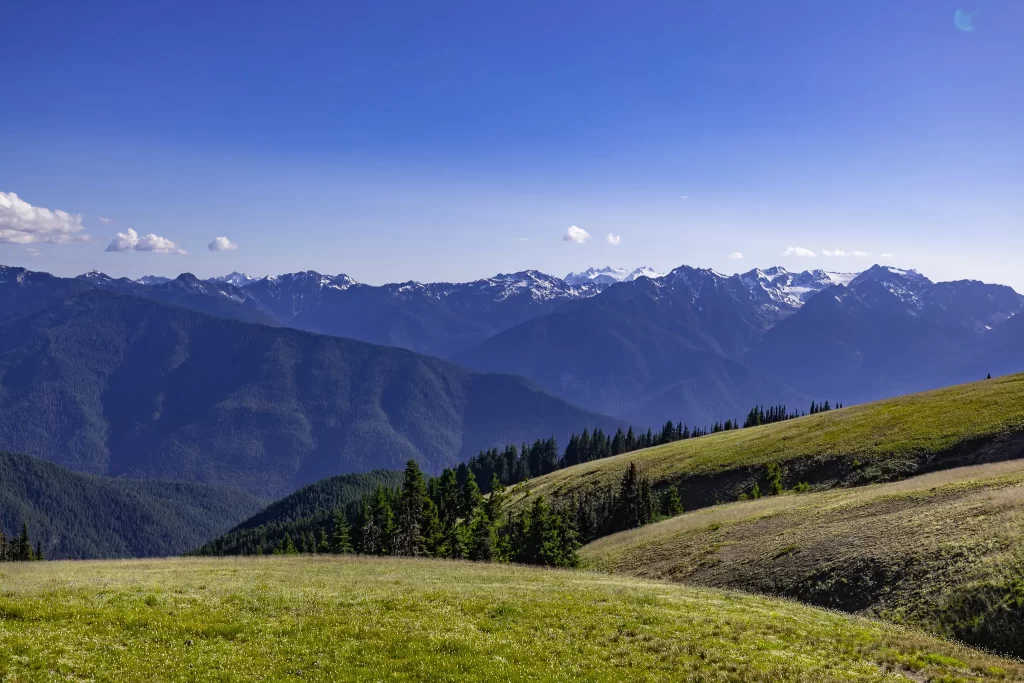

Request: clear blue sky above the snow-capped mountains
left=0, top=0, right=1024, bottom=291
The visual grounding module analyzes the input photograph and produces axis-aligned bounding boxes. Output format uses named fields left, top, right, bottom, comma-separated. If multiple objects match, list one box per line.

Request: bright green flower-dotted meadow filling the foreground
left=0, top=557, right=1024, bottom=683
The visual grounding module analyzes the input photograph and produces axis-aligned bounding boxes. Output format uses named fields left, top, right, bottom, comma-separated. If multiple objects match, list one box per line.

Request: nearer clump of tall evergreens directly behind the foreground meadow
left=225, top=460, right=682, bottom=567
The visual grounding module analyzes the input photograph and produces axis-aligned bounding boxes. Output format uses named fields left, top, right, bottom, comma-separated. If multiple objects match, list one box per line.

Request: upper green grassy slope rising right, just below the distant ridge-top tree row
left=518, top=375, right=1024, bottom=510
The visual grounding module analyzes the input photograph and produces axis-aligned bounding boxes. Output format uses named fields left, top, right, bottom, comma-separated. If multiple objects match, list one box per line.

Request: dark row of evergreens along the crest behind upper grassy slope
left=468, top=400, right=843, bottom=493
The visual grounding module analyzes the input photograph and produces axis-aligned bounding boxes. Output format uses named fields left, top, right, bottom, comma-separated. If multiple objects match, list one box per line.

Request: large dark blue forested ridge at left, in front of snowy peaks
left=0, top=291, right=618, bottom=498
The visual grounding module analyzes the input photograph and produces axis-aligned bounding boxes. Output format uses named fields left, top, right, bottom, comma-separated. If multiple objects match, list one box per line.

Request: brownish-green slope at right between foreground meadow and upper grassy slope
left=582, top=460, right=1024, bottom=655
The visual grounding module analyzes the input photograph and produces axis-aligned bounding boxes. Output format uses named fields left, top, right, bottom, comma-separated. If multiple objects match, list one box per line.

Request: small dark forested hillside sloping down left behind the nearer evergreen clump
left=195, top=470, right=402, bottom=555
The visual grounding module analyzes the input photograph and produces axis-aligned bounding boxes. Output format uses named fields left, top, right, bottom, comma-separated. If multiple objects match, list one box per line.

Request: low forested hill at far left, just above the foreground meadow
left=0, top=452, right=262, bottom=558
